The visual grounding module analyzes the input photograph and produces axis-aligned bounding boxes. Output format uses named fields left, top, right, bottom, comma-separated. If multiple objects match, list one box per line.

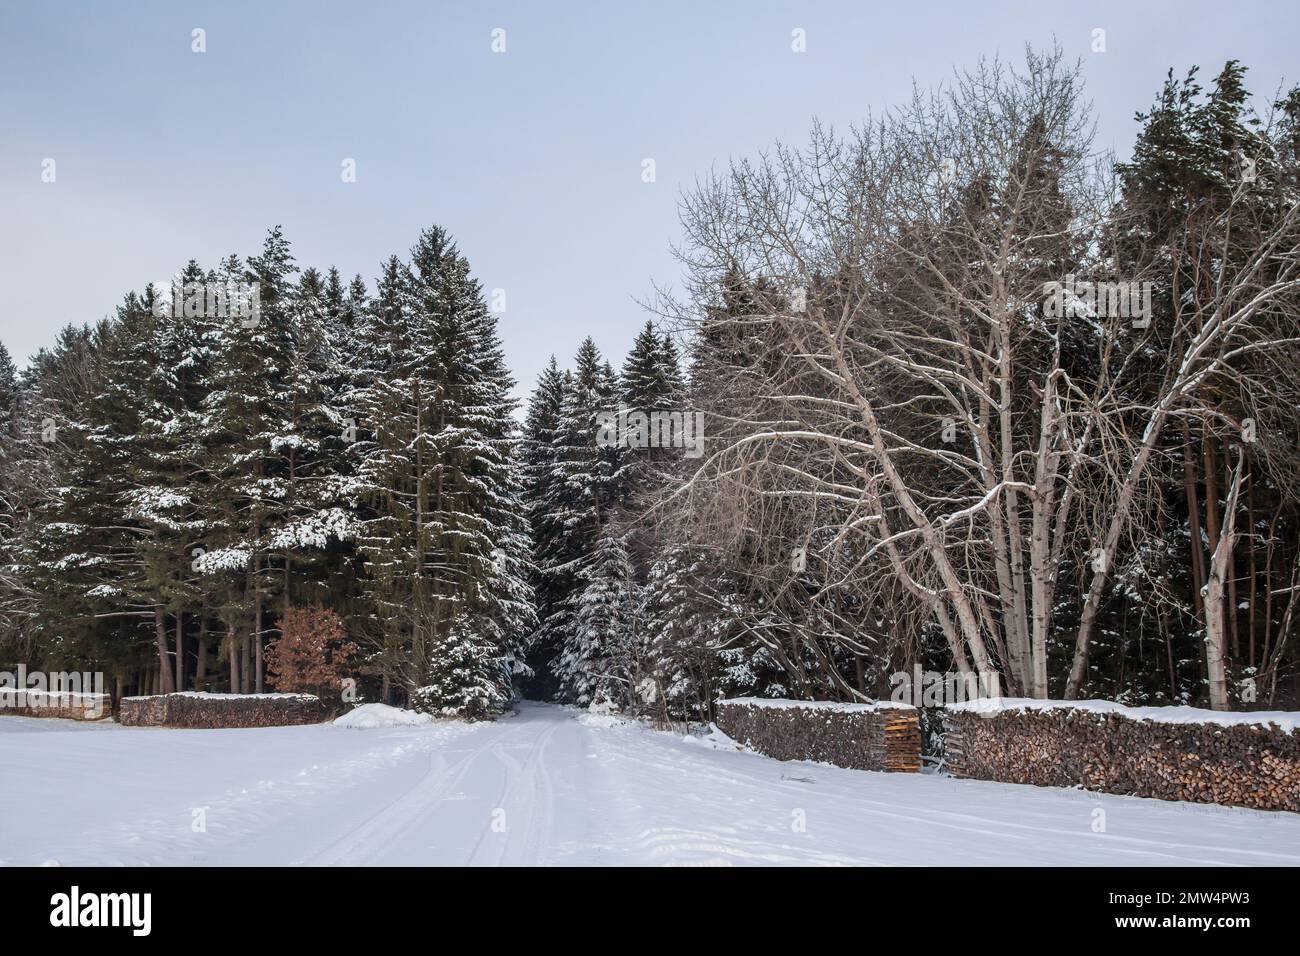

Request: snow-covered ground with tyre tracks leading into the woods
left=0, top=705, right=1300, bottom=866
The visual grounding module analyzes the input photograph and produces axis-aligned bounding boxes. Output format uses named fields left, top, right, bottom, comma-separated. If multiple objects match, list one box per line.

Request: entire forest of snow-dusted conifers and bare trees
left=0, top=51, right=1300, bottom=719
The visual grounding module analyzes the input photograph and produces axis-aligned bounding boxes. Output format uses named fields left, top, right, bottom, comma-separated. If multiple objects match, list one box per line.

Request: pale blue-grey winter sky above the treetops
left=0, top=0, right=1300, bottom=394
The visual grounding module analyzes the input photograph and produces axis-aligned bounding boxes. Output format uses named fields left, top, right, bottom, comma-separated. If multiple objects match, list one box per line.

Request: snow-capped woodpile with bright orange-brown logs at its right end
left=718, top=697, right=920, bottom=774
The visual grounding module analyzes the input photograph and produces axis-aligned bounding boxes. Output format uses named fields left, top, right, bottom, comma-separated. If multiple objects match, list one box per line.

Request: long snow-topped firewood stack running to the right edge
left=944, top=698, right=1300, bottom=812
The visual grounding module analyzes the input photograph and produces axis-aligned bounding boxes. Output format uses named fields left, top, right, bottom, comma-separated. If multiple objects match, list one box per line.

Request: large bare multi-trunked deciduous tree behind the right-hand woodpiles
left=666, top=52, right=1300, bottom=697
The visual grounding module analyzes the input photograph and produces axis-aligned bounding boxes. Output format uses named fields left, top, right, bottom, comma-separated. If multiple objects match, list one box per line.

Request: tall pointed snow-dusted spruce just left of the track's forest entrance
left=356, top=228, right=534, bottom=715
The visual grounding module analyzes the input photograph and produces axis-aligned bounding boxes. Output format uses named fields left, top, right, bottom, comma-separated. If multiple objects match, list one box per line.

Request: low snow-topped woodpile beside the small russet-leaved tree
left=117, top=691, right=328, bottom=728
